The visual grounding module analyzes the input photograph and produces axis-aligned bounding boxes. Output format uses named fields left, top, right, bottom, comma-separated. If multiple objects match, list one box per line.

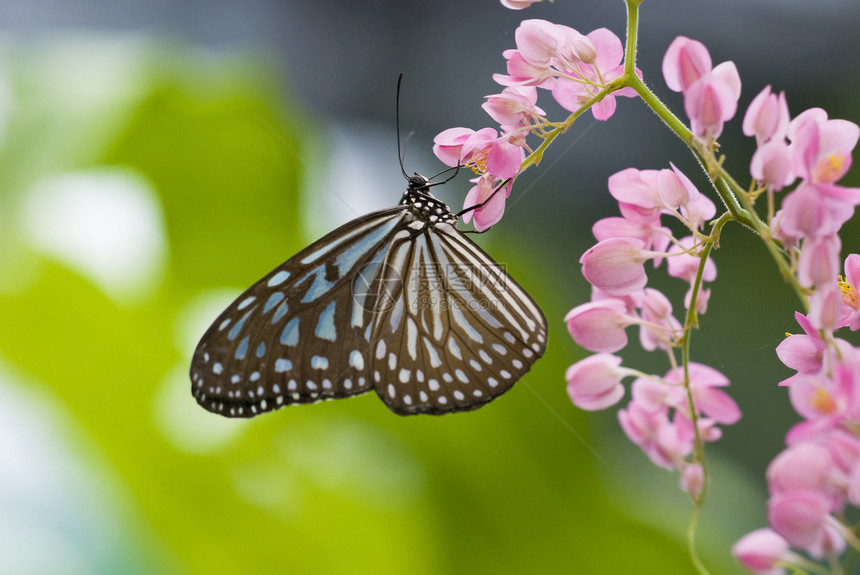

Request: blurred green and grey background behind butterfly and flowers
left=0, top=0, right=858, bottom=575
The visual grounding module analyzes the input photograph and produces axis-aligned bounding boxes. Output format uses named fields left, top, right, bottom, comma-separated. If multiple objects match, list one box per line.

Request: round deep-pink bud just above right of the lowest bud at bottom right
left=767, top=489, right=830, bottom=549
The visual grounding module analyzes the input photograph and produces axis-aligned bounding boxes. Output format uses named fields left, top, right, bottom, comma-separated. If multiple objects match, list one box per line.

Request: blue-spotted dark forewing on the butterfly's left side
left=191, top=206, right=410, bottom=417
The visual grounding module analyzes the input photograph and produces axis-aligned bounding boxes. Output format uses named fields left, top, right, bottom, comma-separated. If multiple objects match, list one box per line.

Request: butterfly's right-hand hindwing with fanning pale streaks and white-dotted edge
left=369, top=223, right=547, bottom=415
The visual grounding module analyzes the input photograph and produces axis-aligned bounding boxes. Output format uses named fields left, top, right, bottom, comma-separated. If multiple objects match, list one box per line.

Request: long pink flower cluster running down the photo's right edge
left=734, top=95, right=860, bottom=573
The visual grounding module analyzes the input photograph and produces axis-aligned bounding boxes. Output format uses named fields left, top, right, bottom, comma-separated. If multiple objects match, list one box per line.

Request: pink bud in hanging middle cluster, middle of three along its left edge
left=564, top=298, right=637, bottom=352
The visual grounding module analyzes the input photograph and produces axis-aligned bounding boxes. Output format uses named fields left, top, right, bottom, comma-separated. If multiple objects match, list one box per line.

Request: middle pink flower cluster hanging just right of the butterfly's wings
left=565, top=159, right=740, bottom=494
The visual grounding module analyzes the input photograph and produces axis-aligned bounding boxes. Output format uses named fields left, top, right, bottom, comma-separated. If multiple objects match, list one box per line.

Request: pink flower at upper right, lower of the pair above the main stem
left=684, top=62, right=741, bottom=140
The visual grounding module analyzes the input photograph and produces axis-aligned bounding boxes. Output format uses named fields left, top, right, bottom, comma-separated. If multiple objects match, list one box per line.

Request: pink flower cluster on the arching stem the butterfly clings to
left=433, top=20, right=636, bottom=231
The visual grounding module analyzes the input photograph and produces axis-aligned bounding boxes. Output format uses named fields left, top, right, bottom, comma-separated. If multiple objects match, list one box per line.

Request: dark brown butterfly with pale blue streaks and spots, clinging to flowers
left=190, top=173, right=547, bottom=417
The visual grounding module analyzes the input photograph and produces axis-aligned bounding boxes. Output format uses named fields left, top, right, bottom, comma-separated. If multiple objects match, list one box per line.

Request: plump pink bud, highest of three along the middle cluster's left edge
left=579, top=238, right=654, bottom=296
